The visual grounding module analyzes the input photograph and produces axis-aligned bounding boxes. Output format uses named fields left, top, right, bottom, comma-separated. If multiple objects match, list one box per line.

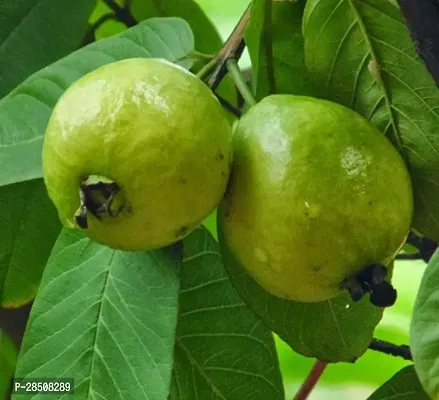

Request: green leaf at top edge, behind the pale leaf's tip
left=131, top=0, right=222, bottom=53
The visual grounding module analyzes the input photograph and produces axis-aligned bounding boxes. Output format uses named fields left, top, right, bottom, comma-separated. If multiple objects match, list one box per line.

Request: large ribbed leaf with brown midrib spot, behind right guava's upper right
left=303, top=0, right=439, bottom=241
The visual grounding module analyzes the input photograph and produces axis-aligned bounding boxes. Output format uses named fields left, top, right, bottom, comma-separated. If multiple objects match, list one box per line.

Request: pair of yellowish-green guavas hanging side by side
left=43, top=58, right=413, bottom=302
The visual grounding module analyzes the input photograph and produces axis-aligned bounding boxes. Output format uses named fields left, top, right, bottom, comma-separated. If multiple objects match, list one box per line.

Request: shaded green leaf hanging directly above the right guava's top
left=245, top=0, right=314, bottom=100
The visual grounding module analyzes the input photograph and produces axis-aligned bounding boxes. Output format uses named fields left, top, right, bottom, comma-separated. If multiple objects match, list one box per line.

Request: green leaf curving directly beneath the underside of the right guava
left=218, top=221, right=383, bottom=362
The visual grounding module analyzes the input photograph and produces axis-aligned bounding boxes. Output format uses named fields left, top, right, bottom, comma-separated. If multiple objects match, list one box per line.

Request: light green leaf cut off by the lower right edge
left=410, top=247, right=439, bottom=398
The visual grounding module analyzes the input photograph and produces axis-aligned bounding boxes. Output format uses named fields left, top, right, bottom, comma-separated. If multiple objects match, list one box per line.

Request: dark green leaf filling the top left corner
left=0, top=0, right=96, bottom=98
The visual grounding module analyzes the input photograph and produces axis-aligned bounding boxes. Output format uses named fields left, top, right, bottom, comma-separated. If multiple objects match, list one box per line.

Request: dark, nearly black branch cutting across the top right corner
left=398, top=0, right=439, bottom=87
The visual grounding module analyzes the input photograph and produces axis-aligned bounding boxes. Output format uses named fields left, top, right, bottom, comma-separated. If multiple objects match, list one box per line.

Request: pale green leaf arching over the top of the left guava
left=0, top=18, right=194, bottom=186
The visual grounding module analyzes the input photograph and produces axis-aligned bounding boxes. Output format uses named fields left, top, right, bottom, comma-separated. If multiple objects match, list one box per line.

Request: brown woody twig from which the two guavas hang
left=207, top=3, right=251, bottom=91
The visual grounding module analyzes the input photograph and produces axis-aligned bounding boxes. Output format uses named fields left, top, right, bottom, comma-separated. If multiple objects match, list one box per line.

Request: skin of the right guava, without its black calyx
left=218, top=95, right=413, bottom=302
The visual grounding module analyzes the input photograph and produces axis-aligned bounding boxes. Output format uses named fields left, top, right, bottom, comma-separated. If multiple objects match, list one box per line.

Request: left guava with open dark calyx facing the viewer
left=42, top=58, right=232, bottom=251
